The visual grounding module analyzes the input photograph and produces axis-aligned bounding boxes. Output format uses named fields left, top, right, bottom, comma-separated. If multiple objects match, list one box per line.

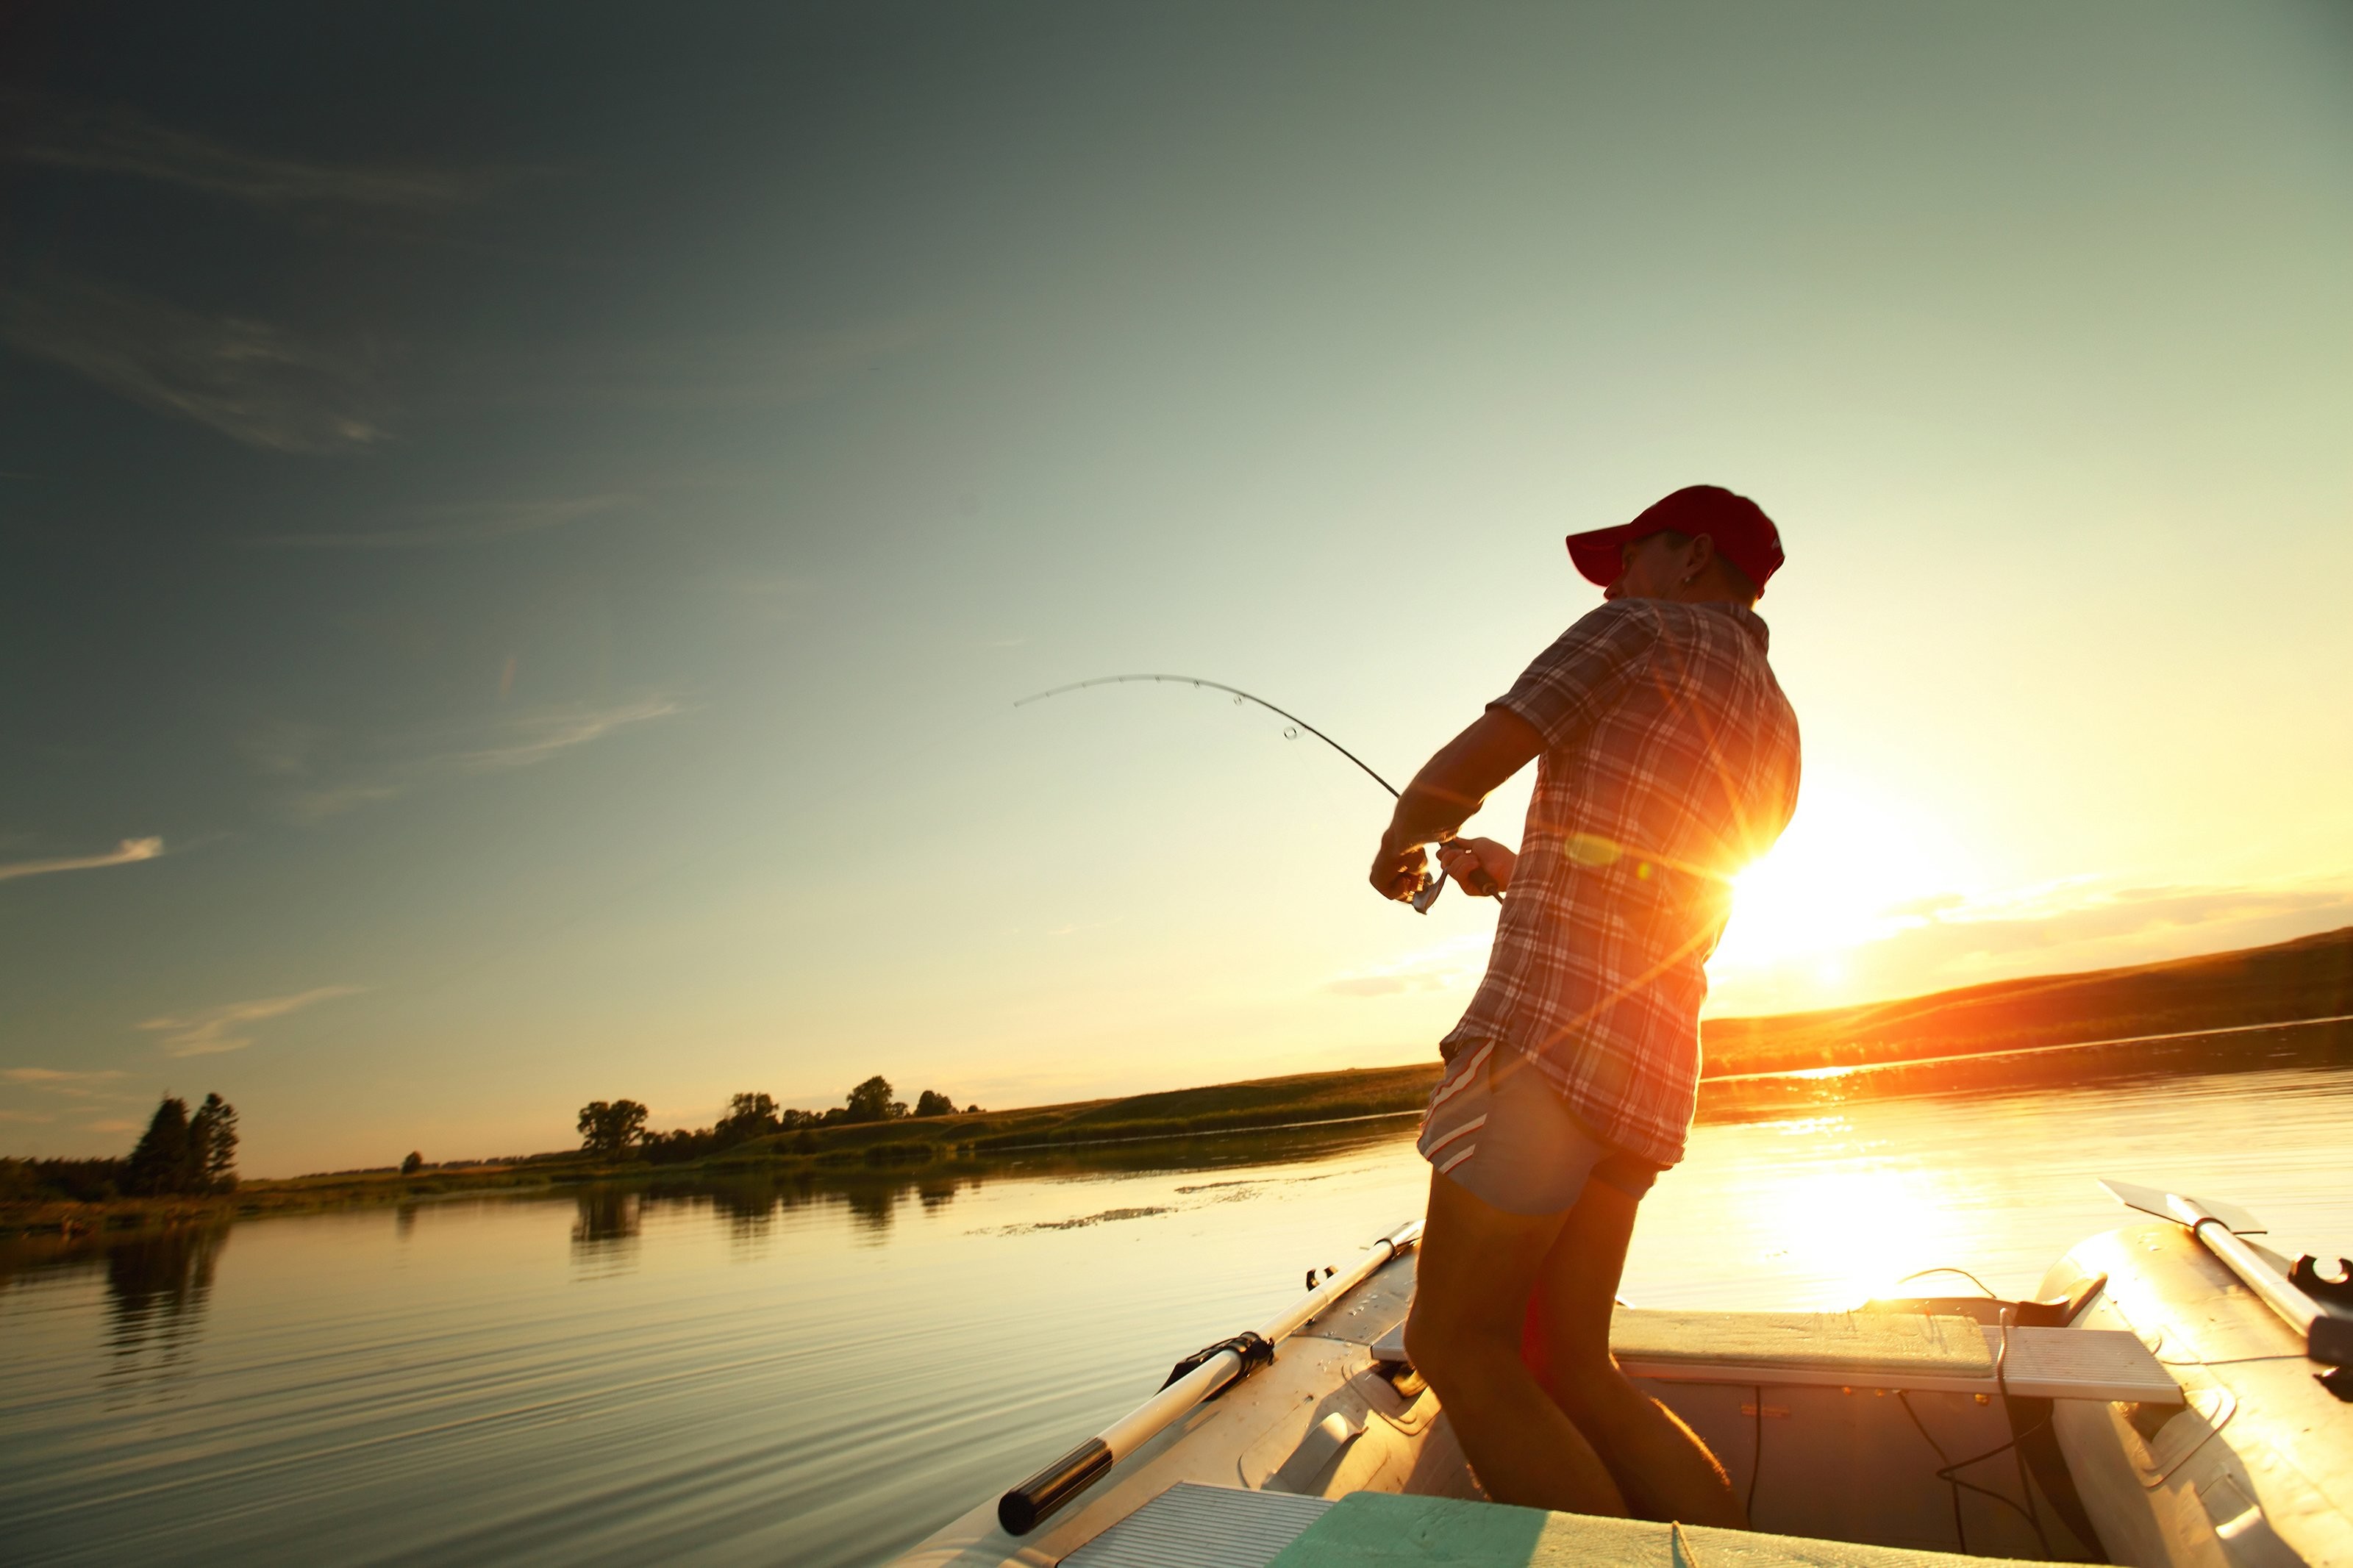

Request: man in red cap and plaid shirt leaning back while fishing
left=1372, top=484, right=1798, bottom=1525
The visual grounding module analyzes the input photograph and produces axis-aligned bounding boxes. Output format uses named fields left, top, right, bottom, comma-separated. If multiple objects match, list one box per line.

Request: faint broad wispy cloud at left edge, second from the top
left=0, top=277, right=388, bottom=451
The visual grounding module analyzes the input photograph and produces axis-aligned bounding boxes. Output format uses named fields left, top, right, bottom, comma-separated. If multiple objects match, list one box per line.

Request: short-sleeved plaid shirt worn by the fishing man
left=1440, top=599, right=1798, bottom=1166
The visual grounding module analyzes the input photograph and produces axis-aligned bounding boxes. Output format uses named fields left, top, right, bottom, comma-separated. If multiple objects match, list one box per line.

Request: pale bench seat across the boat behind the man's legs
left=1372, top=1307, right=2181, bottom=1406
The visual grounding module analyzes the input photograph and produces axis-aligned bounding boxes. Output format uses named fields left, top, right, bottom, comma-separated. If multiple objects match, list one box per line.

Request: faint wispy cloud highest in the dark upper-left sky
left=7, top=99, right=501, bottom=212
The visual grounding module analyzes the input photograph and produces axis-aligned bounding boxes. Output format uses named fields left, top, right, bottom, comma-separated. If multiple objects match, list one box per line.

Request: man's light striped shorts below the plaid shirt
left=1416, top=1042, right=1659, bottom=1215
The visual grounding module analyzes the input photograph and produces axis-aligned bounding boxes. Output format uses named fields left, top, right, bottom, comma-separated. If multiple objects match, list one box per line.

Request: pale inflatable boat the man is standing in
left=899, top=1183, right=2353, bottom=1568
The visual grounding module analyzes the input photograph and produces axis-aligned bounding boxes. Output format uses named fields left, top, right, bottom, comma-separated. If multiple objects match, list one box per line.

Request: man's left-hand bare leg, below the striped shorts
left=1404, top=1171, right=1626, bottom=1517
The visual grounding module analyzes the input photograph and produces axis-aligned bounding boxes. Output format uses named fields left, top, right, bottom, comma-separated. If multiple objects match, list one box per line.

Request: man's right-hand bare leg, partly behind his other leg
left=1534, top=1183, right=1749, bottom=1531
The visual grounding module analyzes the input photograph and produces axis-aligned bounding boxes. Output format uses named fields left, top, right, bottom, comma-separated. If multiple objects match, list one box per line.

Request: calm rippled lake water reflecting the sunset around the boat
left=0, top=1065, right=2353, bottom=1566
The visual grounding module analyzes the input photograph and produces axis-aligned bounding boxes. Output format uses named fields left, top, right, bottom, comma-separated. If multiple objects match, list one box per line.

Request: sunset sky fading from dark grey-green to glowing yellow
left=0, top=0, right=2353, bottom=1175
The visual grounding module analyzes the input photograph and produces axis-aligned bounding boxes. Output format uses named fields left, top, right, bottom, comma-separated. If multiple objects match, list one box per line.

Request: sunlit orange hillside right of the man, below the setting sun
left=1702, top=926, right=2353, bottom=1077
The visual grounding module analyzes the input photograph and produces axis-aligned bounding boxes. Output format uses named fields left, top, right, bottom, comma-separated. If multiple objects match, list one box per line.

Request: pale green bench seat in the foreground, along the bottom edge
left=1261, top=1493, right=2071, bottom=1568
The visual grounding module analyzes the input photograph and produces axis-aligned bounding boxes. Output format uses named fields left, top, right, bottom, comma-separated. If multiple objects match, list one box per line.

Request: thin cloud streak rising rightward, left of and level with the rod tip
left=245, top=696, right=687, bottom=823
